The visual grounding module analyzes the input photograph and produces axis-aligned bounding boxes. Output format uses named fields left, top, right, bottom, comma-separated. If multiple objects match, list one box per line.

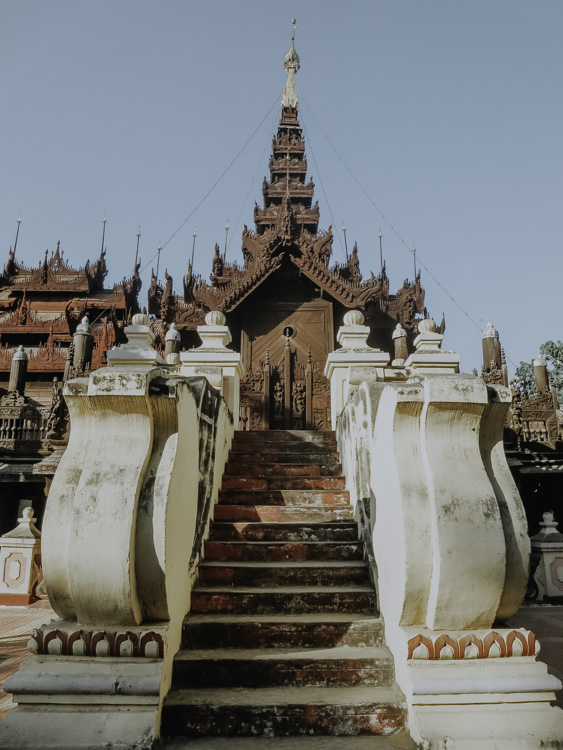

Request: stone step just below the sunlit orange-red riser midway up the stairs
left=209, top=521, right=358, bottom=543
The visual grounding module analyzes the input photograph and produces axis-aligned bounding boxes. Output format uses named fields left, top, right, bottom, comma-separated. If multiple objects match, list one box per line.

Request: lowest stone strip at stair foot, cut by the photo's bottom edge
left=158, top=730, right=417, bottom=750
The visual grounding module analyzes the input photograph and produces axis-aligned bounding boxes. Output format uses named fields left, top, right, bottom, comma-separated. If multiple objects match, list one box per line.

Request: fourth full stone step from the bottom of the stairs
left=191, top=584, right=377, bottom=615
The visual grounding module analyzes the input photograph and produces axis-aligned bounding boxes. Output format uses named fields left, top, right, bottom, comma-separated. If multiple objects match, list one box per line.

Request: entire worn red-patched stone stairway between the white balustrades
left=162, top=431, right=415, bottom=750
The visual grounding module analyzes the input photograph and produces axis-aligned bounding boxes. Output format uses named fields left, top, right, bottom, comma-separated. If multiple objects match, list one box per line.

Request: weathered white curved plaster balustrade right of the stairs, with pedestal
left=337, top=376, right=563, bottom=750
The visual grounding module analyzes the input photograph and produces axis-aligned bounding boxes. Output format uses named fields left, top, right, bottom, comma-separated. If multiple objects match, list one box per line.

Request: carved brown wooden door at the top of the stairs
left=241, top=300, right=333, bottom=430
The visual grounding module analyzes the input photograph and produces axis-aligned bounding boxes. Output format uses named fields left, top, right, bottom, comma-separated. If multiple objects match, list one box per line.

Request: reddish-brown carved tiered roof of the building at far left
left=0, top=243, right=141, bottom=403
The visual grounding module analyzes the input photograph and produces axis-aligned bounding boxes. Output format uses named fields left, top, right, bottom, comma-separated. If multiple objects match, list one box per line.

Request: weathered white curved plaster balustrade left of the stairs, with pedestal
left=0, top=372, right=233, bottom=750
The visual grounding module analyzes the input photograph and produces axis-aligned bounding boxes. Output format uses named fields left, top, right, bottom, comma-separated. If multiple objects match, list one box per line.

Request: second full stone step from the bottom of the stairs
left=172, top=646, right=393, bottom=690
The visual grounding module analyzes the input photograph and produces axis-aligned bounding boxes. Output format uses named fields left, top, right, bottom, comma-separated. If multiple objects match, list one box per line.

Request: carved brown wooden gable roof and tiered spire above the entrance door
left=149, top=101, right=424, bottom=329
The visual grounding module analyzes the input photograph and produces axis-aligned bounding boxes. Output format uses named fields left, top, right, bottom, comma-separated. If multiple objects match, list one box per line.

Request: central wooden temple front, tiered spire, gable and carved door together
left=149, top=106, right=436, bottom=429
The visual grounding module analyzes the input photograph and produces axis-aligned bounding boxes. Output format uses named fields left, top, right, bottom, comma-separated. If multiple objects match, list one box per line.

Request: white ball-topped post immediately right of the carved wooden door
left=324, top=310, right=390, bottom=430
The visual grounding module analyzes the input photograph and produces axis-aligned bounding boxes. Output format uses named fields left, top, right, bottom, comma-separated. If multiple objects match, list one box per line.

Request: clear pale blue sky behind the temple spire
left=0, top=0, right=563, bottom=374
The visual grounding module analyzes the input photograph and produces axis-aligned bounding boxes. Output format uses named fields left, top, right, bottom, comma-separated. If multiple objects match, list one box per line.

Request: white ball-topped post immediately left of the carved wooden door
left=180, top=310, right=244, bottom=430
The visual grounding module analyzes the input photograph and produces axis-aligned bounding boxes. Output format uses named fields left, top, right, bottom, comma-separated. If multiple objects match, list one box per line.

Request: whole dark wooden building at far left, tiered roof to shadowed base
left=0, top=243, right=141, bottom=534
